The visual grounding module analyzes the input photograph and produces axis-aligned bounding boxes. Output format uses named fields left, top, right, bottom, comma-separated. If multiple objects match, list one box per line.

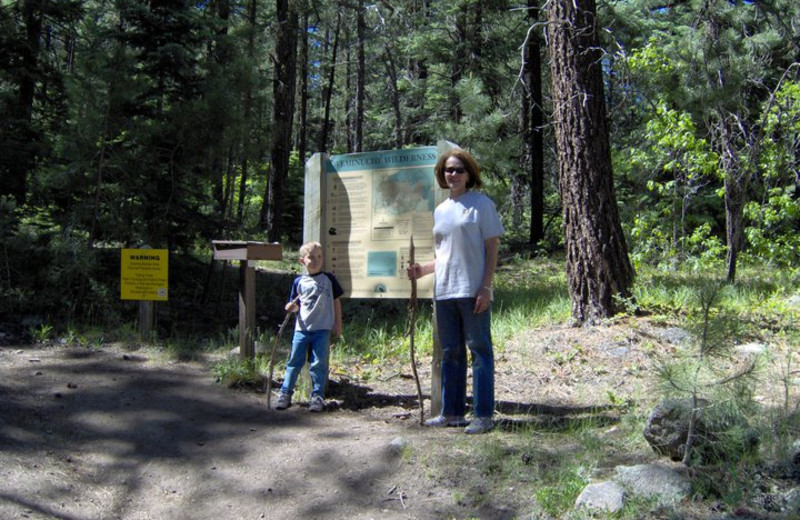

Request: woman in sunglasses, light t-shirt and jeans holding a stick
left=408, top=148, right=503, bottom=433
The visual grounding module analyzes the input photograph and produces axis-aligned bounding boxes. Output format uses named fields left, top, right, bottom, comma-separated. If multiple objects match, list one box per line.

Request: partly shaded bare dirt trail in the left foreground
left=0, top=347, right=482, bottom=520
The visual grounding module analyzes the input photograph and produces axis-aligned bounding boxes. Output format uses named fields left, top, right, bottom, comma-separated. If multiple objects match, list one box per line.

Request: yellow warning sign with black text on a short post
left=120, top=249, right=169, bottom=301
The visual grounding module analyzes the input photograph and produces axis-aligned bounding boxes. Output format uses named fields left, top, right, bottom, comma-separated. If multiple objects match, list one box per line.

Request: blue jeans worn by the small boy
left=281, top=330, right=331, bottom=398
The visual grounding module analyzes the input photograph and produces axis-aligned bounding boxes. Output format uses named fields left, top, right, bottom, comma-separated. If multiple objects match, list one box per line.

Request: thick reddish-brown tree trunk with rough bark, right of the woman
left=548, top=0, right=634, bottom=325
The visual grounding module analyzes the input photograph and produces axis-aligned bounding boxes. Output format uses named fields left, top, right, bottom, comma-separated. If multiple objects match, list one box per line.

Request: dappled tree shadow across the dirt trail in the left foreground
left=0, top=349, right=401, bottom=519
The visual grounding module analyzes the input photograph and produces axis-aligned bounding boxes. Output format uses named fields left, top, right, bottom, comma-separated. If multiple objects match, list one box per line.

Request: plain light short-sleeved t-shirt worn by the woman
left=433, top=190, right=505, bottom=300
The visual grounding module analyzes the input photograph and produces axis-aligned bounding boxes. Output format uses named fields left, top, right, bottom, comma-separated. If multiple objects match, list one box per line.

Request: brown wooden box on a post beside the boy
left=211, top=240, right=283, bottom=360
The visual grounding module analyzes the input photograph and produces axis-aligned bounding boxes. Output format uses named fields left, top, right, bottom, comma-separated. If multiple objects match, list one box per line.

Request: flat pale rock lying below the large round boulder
left=614, top=464, right=692, bottom=504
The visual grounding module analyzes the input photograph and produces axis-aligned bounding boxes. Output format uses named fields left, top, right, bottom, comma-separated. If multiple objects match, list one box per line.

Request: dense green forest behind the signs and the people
left=0, top=0, right=800, bottom=334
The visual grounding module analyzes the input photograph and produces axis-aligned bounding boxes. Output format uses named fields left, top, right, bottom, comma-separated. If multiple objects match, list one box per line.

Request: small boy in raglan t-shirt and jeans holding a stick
left=275, top=242, right=344, bottom=412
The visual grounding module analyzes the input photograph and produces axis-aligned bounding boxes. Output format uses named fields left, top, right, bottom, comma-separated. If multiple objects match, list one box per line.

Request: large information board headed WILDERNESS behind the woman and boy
left=320, top=147, right=447, bottom=298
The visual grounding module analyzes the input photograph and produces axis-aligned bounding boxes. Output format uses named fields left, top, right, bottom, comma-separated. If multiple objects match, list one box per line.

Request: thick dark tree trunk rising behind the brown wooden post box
left=262, top=0, right=298, bottom=242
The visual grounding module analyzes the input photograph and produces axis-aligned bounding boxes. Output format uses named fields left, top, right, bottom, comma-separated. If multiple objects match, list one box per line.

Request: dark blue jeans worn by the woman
left=435, top=298, right=494, bottom=418
